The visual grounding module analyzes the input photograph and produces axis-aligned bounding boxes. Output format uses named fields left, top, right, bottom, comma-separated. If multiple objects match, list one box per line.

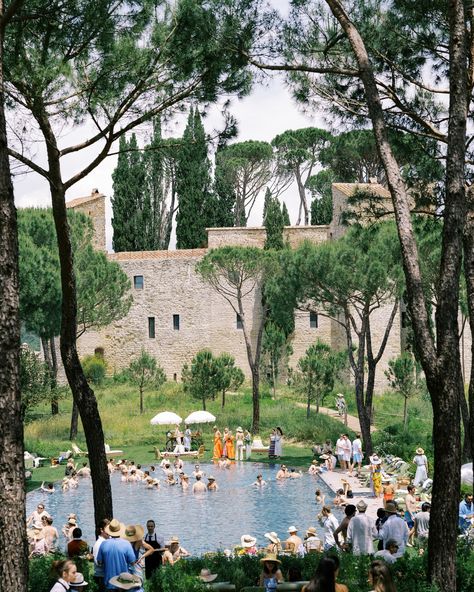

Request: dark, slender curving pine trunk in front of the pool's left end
left=38, top=110, right=113, bottom=526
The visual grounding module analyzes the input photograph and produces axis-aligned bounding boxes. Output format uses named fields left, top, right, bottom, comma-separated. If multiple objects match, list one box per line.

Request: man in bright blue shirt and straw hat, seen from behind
left=97, top=518, right=136, bottom=590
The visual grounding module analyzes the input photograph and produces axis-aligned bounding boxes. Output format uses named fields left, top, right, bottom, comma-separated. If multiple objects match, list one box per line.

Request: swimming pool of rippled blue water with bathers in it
left=26, top=463, right=342, bottom=554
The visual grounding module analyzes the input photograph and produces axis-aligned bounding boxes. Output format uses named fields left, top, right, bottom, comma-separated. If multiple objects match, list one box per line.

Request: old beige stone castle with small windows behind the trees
left=67, top=183, right=471, bottom=389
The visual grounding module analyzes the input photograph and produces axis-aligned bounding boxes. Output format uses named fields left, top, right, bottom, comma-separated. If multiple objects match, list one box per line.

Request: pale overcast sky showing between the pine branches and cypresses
left=14, top=0, right=322, bottom=250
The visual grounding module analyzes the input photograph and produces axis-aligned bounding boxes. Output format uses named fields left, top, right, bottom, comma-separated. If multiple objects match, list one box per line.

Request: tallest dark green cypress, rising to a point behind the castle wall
left=176, top=108, right=212, bottom=249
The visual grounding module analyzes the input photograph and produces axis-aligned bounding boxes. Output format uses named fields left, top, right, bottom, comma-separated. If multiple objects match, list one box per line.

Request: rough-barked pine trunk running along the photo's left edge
left=0, top=0, right=28, bottom=592
